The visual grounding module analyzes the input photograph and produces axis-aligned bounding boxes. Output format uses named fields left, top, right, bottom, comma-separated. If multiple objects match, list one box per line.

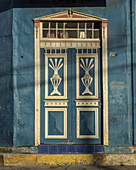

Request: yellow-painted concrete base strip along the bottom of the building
left=0, top=154, right=136, bottom=166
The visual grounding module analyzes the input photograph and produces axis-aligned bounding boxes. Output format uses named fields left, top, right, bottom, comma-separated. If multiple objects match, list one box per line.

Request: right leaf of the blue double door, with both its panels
left=73, top=50, right=101, bottom=144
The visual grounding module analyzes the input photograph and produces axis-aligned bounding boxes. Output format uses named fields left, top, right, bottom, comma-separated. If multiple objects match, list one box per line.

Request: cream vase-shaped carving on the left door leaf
left=49, top=58, right=63, bottom=96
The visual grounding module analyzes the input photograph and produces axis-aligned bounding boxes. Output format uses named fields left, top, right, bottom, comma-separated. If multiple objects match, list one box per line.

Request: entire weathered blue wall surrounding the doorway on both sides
left=0, top=0, right=136, bottom=146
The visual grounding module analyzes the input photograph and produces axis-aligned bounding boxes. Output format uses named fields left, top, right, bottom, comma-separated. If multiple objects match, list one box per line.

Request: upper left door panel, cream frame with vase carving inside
left=45, top=54, right=67, bottom=99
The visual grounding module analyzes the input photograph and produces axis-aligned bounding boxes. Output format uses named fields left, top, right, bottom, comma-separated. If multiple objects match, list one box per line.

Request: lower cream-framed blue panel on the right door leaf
left=77, top=108, right=98, bottom=138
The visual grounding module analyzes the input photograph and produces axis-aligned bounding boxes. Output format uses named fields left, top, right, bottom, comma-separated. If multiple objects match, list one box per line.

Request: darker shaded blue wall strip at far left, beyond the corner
left=0, top=10, right=13, bottom=146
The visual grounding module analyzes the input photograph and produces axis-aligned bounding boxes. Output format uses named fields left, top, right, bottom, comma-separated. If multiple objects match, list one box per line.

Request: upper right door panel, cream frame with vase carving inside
left=76, top=53, right=98, bottom=99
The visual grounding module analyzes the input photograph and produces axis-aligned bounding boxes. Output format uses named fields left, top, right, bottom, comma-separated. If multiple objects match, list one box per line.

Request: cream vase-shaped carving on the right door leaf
left=80, top=58, right=94, bottom=95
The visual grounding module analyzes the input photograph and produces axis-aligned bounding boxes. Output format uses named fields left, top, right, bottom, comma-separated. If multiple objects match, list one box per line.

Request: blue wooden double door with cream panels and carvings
left=41, top=48, right=102, bottom=144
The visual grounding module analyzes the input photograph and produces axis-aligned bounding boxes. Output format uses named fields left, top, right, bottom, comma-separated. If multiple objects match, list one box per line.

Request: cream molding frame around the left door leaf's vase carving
left=45, top=53, right=67, bottom=99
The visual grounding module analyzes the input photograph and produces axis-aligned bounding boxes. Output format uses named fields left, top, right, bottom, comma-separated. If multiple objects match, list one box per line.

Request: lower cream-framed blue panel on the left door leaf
left=45, top=108, right=67, bottom=139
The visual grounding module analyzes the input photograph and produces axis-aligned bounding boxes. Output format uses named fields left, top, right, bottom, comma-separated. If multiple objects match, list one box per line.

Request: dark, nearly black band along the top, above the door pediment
left=0, top=0, right=106, bottom=12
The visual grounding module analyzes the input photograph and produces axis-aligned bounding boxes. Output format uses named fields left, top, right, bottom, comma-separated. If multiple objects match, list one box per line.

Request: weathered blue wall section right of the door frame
left=107, top=1, right=132, bottom=145
